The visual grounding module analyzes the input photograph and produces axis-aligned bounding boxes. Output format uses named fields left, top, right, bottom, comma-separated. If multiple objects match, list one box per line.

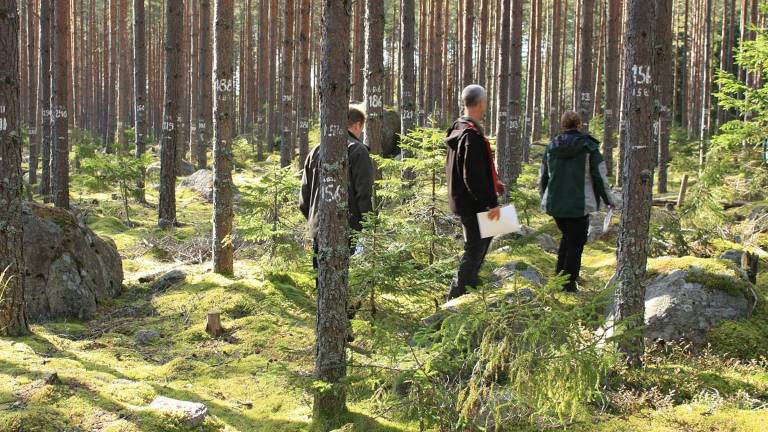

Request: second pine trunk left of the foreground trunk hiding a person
left=280, top=0, right=296, bottom=167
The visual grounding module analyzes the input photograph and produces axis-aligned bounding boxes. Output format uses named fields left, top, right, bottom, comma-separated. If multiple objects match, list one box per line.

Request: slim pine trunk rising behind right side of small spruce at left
left=133, top=0, right=147, bottom=202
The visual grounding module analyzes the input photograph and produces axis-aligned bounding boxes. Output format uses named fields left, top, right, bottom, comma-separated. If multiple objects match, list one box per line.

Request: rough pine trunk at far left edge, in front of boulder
left=0, top=0, right=30, bottom=336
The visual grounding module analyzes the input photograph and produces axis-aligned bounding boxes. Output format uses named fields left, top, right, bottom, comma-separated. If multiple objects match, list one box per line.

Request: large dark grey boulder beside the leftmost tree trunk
left=22, top=202, right=123, bottom=321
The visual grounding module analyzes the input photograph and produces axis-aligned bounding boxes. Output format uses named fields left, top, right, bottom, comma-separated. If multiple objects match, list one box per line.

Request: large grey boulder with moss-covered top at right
left=606, top=257, right=754, bottom=344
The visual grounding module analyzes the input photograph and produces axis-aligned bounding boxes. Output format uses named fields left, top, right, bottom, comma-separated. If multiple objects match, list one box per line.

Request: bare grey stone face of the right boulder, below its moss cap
left=603, top=270, right=750, bottom=344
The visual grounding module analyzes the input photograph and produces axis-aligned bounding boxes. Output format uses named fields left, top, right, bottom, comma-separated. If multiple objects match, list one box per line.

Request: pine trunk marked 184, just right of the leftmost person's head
left=363, top=0, right=384, bottom=155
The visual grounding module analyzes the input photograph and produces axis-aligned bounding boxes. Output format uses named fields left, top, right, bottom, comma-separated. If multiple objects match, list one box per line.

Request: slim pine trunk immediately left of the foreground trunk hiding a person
left=296, top=0, right=312, bottom=164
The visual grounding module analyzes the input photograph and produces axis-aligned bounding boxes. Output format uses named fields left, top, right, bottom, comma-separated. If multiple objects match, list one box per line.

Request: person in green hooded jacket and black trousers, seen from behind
left=539, top=111, right=613, bottom=292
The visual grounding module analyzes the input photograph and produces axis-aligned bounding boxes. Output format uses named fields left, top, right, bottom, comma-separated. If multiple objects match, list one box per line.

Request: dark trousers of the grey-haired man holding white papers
left=448, top=215, right=493, bottom=300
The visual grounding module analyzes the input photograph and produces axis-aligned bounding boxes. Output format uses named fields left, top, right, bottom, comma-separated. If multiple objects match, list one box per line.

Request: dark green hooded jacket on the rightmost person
left=539, top=130, right=613, bottom=218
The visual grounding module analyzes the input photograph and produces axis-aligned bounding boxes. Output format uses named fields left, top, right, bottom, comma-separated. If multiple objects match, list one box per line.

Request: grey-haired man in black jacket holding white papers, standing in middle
left=445, top=85, right=505, bottom=300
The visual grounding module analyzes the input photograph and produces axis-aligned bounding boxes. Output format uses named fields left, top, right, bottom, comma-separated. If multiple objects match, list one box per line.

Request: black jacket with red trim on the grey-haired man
left=445, top=117, right=503, bottom=216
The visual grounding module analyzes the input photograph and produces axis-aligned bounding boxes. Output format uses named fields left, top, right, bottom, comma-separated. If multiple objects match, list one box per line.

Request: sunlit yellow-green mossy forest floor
left=0, top=136, right=768, bottom=432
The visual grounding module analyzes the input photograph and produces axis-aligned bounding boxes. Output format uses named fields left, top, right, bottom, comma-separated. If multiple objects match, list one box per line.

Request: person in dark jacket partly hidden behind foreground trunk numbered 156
left=299, top=105, right=374, bottom=245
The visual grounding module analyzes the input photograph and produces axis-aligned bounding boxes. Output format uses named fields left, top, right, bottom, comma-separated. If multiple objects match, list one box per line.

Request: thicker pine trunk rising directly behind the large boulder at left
left=51, top=1, right=70, bottom=209
